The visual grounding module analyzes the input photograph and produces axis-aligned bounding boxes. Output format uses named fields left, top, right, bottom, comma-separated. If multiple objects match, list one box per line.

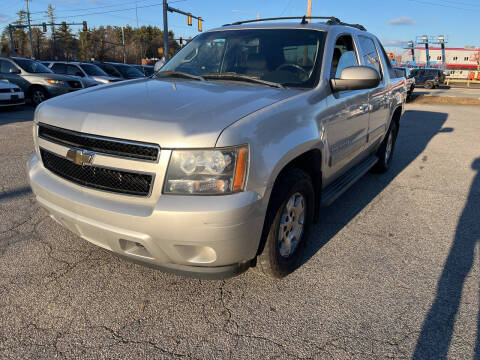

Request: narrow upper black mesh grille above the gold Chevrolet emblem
left=38, top=124, right=159, bottom=161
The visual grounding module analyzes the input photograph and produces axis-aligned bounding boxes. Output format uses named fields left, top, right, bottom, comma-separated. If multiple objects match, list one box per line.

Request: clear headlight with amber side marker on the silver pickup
left=164, top=146, right=248, bottom=195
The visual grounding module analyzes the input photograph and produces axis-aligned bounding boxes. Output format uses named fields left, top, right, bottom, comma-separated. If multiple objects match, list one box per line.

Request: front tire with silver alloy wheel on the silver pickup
left=256, top=169, right=315, bottom=278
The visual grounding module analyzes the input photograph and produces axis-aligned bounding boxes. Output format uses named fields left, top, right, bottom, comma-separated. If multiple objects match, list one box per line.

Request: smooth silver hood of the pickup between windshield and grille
left=35, top=79, right=300, bottom=148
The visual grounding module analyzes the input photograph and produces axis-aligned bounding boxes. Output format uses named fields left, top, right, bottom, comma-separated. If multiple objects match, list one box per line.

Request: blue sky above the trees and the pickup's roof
left=0, top=0, right=480, bottom=50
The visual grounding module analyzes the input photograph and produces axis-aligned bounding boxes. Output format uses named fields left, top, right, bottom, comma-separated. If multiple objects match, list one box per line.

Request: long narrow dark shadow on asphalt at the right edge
left=413, top=158, right=480, bottom=359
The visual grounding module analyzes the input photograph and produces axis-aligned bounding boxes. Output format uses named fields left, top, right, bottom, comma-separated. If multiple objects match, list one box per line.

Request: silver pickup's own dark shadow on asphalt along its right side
left=302, top=110, right=453, bottom=264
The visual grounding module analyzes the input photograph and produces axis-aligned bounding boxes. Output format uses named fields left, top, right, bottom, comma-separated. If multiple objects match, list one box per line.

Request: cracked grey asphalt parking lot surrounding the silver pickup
left=0, top=105, right=480, bottom=359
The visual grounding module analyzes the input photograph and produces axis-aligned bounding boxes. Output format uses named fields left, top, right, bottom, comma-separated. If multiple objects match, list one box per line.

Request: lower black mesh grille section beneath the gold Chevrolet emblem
left=40, top=149, right=153, bottom=196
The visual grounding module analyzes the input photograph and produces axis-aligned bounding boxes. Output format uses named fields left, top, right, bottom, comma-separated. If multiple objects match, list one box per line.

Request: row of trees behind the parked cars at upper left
left=0, top=4, right=180, bottom=64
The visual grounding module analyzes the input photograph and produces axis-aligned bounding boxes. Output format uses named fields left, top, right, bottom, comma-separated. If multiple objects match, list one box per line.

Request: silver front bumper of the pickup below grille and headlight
left=27, top=154, right=265, bottom=278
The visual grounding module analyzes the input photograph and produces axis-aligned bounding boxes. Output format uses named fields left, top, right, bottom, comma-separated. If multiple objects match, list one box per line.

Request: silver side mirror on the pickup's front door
left=330, top=66, right=380, bottom=92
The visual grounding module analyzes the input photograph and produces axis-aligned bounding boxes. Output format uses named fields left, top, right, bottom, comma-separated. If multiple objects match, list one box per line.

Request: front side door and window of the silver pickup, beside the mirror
left=325, top=34, right=369, bottom=174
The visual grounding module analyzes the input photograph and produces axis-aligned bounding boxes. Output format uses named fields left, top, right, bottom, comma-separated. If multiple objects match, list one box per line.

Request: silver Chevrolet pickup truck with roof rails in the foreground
left=27, top=18, right=406, bottom=278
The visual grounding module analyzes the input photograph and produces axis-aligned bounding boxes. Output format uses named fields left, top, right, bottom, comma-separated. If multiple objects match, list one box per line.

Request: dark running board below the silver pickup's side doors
left=320, top=155, right=378, bottom=206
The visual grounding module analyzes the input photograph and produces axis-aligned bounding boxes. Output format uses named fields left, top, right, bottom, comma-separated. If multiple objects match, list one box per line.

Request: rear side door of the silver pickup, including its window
left=358, top=35, right=391, bottom=144
